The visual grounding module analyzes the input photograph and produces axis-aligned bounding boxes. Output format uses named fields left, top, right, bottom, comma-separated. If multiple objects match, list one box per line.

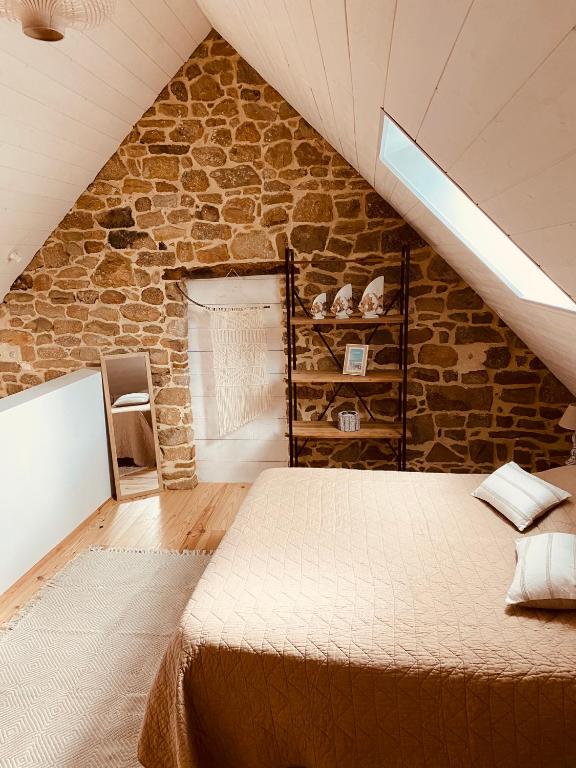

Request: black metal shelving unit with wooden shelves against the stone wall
left=285, top=245, right=410, bottom=471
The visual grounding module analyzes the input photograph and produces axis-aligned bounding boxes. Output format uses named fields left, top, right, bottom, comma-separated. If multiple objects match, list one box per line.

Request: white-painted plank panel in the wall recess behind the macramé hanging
left=187, top=276, right=288, bottom=483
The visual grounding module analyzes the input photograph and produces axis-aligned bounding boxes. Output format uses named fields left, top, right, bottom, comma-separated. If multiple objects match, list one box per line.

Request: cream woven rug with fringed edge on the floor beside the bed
left=0, top=549, right=210, bottom=768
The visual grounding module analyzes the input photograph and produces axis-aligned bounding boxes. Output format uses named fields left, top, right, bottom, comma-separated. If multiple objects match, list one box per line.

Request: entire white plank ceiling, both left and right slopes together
left=0, top=0, right=576, bottom=393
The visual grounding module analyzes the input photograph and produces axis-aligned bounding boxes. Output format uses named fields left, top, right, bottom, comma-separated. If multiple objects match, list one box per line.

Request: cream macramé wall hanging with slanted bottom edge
left=210, top=307, right=270, bottom=435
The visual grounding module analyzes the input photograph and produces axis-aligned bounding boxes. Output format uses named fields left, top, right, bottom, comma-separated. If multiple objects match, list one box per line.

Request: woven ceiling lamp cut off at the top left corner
left=0, top=0, right=116, bottom=43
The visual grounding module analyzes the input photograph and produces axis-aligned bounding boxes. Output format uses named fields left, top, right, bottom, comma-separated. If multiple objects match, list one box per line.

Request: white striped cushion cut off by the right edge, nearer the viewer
left=506, top=533, right=576, bottom=609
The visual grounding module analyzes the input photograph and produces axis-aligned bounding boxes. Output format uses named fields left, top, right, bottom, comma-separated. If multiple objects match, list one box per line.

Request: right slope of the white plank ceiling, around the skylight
left=199, top=0, right=576, bottom=393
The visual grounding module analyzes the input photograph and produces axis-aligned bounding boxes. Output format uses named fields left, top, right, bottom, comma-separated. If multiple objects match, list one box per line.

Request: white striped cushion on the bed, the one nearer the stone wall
left=472, top=461, right=571, bottom=531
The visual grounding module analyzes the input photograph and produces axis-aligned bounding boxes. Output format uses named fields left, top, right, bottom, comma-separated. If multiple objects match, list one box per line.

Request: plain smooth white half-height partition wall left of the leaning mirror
left=0, top=370, right=111, bottom=593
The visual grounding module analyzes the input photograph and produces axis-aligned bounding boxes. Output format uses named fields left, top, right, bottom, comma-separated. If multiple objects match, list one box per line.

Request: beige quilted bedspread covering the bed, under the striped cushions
left=140, top=468, right=576, bottom=768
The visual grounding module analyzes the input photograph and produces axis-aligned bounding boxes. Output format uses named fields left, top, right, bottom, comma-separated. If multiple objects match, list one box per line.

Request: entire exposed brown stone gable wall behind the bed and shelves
left=0, top=33, right=571, bottom=488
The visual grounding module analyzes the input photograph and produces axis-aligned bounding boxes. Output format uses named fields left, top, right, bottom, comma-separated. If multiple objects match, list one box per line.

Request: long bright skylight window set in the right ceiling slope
left=380, top=115, right=576, bottom=312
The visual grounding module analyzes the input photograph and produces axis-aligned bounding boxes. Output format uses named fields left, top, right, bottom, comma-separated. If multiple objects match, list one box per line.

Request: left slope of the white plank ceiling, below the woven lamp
left=0, top=0, right=210, bottom=301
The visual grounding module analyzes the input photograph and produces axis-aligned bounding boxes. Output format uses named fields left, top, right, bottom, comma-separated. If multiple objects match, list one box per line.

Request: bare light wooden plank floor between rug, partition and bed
left=0, top=483, right=250, bottom=624
